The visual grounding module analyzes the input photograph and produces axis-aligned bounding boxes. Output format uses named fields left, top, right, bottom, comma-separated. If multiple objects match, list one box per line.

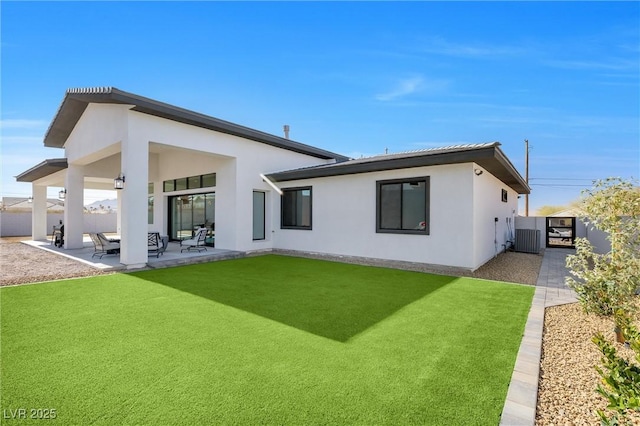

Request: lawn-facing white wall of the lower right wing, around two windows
left=273, top=164, right=484, bottom=269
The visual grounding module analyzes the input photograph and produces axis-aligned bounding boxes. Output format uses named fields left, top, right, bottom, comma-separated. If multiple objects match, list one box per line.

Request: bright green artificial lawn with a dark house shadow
left=0, top=255, right=534, bottom=425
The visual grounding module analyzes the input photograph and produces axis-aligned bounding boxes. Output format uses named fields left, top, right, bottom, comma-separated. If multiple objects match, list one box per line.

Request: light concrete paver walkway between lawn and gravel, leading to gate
left=500, top=249, right=578, bottom=426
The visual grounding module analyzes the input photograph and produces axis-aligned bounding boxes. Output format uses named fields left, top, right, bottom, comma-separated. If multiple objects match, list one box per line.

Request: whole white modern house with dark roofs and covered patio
left=17, top=87, right=529, bottom=270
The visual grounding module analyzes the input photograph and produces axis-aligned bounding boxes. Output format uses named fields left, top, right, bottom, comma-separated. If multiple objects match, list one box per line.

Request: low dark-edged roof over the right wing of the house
left=267, top=142, right=531, bottom=194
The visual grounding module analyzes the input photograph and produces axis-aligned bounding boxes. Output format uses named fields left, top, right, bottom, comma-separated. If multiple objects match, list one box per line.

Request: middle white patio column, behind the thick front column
left=64, top=164, right=84, bottom=249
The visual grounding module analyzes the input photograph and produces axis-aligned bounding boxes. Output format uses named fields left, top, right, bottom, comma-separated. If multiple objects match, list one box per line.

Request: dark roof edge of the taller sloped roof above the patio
left=44, top=87, right=348, bottom=161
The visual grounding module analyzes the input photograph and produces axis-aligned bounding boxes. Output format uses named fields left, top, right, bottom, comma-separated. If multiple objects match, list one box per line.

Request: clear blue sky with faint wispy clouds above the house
left=0, top=1, right=640, bottom=212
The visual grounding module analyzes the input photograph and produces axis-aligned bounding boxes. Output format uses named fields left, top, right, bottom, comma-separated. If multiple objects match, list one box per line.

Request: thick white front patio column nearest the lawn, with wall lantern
left=119, top=133, right=149, bottom=269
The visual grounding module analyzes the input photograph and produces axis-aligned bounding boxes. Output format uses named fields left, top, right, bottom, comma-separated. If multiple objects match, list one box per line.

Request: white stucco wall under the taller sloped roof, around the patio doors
left=128, top=111, right=332, bottom=255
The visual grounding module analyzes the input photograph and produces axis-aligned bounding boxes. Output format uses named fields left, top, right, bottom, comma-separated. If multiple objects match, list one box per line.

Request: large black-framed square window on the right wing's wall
left=376, top=177, right=429, bottom=235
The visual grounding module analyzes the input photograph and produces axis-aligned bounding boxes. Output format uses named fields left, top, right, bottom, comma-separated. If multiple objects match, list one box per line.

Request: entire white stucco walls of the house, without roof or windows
left=53, top=104, right=517, bottom=269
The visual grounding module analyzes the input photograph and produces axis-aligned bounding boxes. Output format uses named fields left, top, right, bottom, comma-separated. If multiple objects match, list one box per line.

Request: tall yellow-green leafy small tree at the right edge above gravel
left=566, top=178, right=640, bottom=317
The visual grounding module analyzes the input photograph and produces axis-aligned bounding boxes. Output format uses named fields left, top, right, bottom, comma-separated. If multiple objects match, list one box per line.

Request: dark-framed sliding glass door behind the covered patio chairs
left=169, top=192, right=216, bottom=240
